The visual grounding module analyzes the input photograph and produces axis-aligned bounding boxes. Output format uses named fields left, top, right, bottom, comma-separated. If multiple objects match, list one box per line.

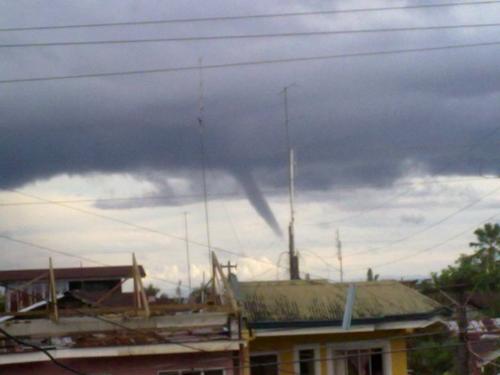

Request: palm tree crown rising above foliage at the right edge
left=469, top=223, right=500, bottom=274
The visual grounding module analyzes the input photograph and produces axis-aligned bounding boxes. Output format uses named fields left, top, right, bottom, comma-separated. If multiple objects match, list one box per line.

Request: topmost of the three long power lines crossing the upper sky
left=0, top=0, right=500, bottom=31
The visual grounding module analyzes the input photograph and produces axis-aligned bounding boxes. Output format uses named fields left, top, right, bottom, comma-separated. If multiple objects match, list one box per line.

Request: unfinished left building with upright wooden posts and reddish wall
left=0, top=256, right=245, bottom=375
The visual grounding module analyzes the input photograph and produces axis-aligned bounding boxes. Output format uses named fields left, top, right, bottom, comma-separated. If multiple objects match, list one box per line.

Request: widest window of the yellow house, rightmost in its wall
left=331, top=342, right=391, bottom=375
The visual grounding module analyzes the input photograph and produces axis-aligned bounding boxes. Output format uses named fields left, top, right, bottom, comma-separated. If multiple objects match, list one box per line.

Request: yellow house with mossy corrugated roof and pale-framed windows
left=232, top=277, right=445, bottom=375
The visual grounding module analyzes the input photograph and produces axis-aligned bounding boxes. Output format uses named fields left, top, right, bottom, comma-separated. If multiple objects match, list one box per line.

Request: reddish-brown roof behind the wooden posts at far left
left=0, top=266, right=146, bottom=283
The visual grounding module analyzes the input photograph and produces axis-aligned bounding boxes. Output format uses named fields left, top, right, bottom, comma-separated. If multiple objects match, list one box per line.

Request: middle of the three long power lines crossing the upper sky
left=4, top=23, right=500, bottom=48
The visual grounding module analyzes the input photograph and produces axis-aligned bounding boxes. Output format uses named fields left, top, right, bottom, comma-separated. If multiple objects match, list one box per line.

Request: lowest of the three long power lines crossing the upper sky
left=4, top=41, right=500, bottom=84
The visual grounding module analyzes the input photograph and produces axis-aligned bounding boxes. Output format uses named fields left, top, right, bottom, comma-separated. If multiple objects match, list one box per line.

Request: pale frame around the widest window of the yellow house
left=326, top=340, right=392, bottom=375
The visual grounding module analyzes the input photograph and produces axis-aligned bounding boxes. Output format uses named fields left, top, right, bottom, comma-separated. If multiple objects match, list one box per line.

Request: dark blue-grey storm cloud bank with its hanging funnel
left=0, top=1, right=500, bottom=232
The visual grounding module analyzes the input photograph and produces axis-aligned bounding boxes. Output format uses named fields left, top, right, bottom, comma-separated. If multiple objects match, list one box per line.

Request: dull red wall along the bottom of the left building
left=0, top=352, right=233, bottom=375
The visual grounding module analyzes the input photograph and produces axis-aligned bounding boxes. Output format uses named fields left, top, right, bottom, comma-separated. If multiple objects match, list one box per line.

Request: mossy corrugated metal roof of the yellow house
left=239, top=280, right=441, bottom=324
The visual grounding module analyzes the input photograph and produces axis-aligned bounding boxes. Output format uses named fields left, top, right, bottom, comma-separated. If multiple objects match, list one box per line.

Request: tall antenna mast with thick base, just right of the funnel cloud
left=282, top=86, right=300, bottom=280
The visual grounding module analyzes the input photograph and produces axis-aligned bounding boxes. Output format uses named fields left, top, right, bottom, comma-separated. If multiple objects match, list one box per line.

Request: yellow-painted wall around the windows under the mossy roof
left=249, top=331, right=407, bottom=375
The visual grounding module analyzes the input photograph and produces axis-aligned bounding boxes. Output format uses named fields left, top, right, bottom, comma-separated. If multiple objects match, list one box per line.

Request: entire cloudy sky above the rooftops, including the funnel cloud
left=0, top=0, right=500, bottom=291
